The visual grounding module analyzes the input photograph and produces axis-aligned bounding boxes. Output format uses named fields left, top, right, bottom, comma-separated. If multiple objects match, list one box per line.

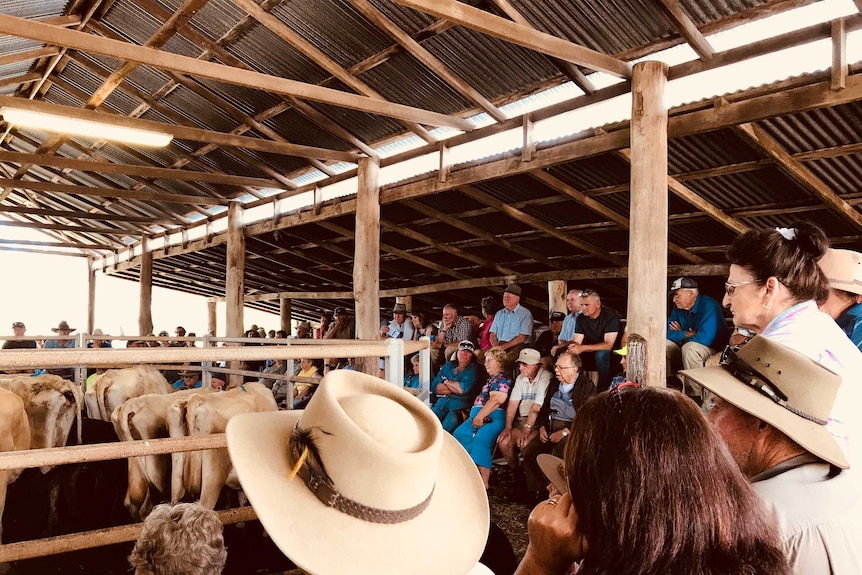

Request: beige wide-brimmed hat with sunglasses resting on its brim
left=680, top=335, right=850, bottom=469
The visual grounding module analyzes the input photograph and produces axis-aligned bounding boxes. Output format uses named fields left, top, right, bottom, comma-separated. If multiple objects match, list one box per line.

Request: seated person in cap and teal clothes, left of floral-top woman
left=431, top=339, right=480, bottom=433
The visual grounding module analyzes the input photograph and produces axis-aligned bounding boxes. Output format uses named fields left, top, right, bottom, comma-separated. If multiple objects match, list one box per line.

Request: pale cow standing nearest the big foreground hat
left=167, top=382, right=278, bottom=509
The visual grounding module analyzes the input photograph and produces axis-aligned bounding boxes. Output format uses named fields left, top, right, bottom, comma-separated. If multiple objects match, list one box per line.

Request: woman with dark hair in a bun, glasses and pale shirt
left=723, top=222, right=862, bottom=455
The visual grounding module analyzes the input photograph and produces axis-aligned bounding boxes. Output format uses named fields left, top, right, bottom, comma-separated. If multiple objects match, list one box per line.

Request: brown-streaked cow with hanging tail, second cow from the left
left=0, top=374, right=84, bottom=460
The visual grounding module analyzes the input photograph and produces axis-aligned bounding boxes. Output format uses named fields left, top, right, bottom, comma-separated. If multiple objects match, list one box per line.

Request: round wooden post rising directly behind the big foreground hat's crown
left=353, top=158, right=380, bottom=375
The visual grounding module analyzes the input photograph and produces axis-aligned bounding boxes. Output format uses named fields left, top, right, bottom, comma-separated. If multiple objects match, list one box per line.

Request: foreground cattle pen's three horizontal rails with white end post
left=0, top=338, right=430, bottom=564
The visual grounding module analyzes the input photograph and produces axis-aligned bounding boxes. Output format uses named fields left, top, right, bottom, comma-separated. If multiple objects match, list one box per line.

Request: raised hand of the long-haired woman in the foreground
left=516, top=493, right=587, bottom=575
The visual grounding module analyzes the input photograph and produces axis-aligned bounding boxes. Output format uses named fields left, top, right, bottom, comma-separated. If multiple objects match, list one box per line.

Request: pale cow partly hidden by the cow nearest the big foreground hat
left=111, top=389, right=215, bottom=521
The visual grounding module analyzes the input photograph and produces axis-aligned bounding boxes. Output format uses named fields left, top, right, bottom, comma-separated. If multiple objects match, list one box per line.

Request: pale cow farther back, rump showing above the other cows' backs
left=84, top=365, right=173, bottom=421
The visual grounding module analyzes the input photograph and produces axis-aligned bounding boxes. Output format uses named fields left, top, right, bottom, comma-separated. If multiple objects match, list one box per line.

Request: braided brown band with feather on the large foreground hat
left=288, top=421, right=434, bottom=525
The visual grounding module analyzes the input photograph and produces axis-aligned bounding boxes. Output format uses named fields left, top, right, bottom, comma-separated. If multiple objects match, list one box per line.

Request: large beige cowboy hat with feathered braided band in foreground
left=227, top=370, right=490, bottom=575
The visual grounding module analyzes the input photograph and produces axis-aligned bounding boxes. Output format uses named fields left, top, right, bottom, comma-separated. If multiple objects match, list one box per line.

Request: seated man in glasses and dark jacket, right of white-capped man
left=523, top=351, right=596, bottom=501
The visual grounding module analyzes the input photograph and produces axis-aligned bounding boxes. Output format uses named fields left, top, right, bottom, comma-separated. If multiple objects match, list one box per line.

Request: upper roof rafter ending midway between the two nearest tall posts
left=346, top=0, right=506, bottom=122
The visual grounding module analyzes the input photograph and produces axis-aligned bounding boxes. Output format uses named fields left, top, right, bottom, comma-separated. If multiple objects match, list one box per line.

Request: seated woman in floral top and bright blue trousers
left=452, top=349, right=512, bottom=489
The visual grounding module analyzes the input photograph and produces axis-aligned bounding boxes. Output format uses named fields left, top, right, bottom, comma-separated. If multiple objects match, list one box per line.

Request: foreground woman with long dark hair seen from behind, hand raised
left=516, top=384, right=790, bottom=575
